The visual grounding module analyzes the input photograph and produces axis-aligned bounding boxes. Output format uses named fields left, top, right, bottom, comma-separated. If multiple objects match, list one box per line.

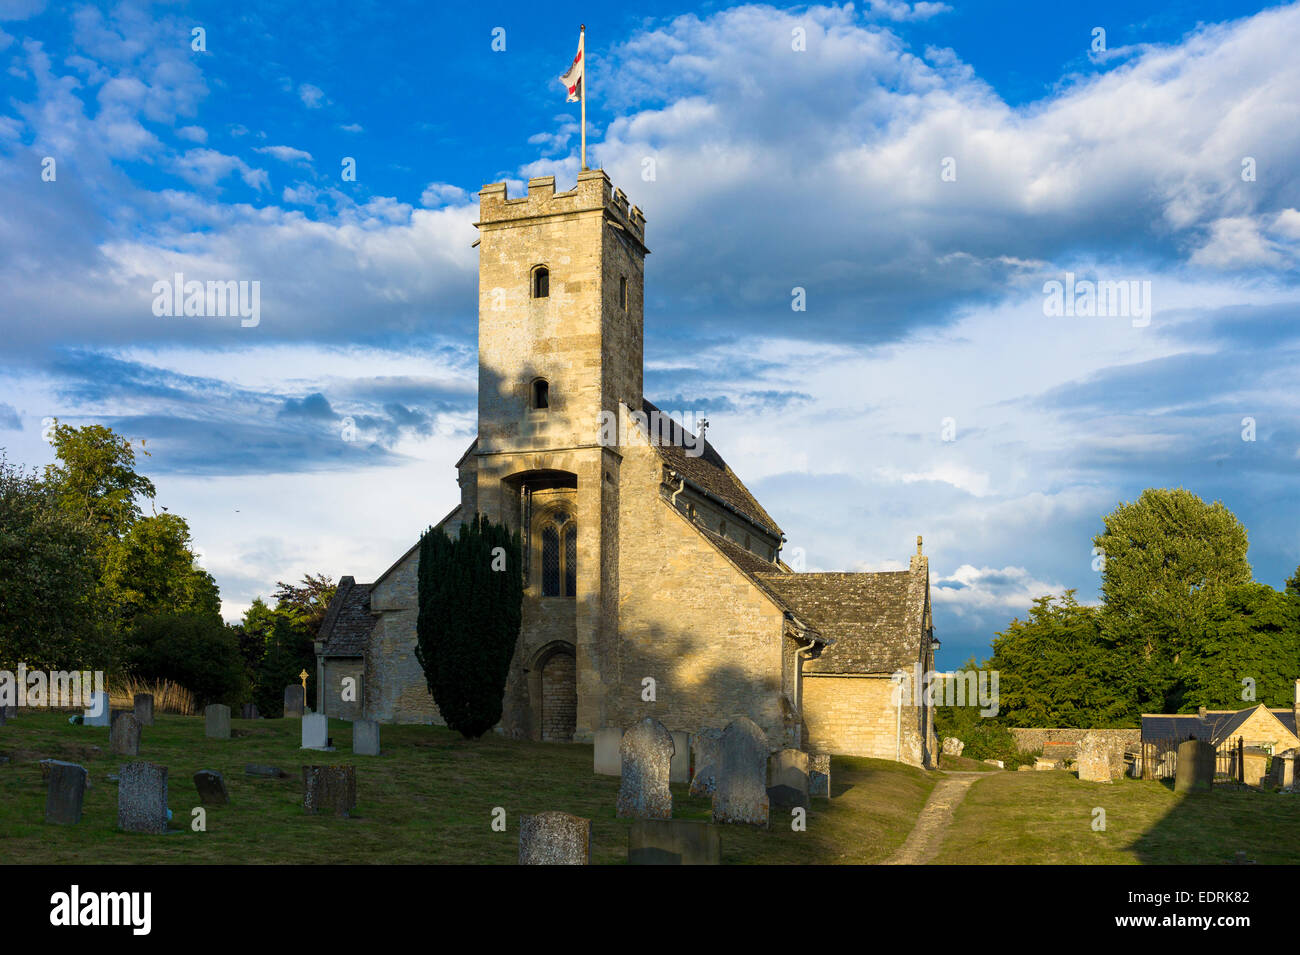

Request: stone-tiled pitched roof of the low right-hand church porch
left=754, top=570, right=924, bottom=673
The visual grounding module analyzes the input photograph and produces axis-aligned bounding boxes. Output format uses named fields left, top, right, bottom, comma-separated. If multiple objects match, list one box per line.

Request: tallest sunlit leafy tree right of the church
left=1093, top=489, right=1251, bottom=712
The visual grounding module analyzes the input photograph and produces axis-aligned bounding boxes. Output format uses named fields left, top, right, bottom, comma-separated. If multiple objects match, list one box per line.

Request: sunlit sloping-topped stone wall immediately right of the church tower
left=606, top=447, right=790, bottom=748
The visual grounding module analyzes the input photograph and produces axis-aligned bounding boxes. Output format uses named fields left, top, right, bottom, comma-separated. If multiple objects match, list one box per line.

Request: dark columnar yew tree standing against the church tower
left=416, top=515, right=524, bottom=739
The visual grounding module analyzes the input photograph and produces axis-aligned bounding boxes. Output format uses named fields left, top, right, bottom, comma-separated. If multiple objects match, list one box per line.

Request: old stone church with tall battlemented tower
left=316, top=169, right=939, bottom=767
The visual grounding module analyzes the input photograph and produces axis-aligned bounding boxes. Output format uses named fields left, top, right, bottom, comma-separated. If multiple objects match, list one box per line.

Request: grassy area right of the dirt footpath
left=935, top=772, right=1300, bottom=864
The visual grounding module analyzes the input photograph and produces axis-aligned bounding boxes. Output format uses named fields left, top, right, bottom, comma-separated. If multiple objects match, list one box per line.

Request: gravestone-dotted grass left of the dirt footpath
left=0, top=713, right=933, bottom=864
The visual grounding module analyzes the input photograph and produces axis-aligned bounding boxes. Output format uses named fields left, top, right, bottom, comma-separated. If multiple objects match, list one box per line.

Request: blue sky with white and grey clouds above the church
left=0, top=0, right=1300, bottom=665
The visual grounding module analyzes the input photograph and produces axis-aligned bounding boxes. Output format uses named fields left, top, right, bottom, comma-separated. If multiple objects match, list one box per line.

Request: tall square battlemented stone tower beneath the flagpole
left=462, top=169, right=647, bottom=737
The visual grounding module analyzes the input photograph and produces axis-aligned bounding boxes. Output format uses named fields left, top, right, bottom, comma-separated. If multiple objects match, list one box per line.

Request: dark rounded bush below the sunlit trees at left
left=126, top=613, right=248, bottom=708
